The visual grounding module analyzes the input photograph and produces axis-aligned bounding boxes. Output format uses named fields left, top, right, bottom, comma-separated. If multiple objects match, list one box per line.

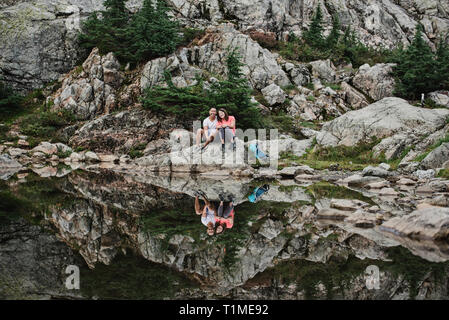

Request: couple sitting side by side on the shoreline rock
left=196, top=108, right=235, bottom=154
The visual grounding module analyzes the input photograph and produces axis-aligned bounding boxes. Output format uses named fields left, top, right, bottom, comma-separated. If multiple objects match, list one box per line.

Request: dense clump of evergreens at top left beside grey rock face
left=79, top=0, right=180, bottom=65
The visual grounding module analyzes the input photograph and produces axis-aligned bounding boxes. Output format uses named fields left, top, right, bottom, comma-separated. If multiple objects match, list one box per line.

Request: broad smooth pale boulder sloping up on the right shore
left=316, top=97, right=449, bottom=157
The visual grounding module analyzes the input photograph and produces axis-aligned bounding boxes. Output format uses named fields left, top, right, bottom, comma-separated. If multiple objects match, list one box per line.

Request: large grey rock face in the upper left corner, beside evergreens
left=0, top=0, right=142, bottom=90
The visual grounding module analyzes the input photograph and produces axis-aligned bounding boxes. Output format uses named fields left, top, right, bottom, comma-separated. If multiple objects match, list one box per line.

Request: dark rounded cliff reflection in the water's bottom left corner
left=0, top=219, right=82, bottom=300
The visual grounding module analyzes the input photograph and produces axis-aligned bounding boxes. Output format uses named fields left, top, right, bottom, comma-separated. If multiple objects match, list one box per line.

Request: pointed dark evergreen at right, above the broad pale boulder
left=393, top=25, right=439, bottom=99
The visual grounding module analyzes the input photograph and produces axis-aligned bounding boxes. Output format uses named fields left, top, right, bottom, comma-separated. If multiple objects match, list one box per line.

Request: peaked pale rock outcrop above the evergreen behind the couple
left=141, top=23, right=291, bottom=90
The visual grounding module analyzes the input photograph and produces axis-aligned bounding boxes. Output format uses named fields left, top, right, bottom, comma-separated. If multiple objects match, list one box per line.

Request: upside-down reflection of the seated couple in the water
left=195, top=191, right=234, bottom=236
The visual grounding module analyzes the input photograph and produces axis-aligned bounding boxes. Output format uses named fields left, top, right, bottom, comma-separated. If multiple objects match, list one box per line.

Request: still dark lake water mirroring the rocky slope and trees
left=0, top=171, right=449, bottom=299
